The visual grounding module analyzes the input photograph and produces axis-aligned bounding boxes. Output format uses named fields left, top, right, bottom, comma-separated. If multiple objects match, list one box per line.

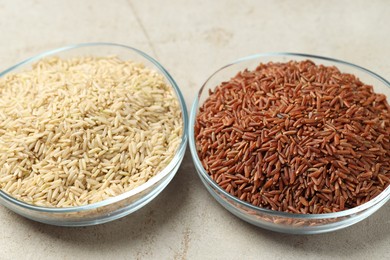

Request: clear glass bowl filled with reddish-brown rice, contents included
left=189, top=53, right=390, bottom=234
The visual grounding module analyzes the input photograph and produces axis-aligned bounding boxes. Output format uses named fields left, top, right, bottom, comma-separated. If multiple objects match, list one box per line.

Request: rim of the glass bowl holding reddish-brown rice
left=188, top=52, right=390, bottom=219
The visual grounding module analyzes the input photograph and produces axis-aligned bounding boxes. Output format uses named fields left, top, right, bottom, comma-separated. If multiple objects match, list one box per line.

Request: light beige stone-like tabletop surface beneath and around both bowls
left=0, top=0, right=390, bottom=259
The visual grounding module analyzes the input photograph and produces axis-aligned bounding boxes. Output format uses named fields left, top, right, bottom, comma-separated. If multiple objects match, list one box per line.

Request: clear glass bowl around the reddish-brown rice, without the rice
left=189, top=53, right=390, bottom=234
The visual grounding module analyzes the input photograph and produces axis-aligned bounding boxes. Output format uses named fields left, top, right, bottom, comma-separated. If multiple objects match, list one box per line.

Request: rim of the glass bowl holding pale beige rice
left=0, top=42, right=188, bottom=213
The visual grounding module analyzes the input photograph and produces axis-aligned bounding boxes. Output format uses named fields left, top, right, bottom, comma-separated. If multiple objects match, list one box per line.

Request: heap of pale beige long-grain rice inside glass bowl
left=0, top=57, right=183, bottom=207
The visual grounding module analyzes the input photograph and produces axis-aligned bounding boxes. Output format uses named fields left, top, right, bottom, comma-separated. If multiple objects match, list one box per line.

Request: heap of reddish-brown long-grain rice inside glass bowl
left=195, top=61, right=390, bottom=213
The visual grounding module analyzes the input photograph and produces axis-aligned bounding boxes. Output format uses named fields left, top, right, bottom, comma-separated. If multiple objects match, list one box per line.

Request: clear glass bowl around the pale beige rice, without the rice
left=0, top=43, right=188, bottom=226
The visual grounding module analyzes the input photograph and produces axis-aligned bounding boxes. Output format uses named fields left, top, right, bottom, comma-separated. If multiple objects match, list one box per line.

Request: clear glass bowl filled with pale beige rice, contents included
left=0, top=43, right=188, bottom=226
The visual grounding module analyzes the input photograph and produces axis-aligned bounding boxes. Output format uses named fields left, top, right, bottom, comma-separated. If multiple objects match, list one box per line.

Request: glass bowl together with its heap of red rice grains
left=189, top=53, right=390, bottom=234
